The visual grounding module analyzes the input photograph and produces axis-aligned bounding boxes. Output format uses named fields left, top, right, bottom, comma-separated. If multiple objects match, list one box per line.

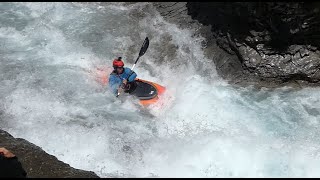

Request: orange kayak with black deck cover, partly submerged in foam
left=95, top=67, right=166, bottom=106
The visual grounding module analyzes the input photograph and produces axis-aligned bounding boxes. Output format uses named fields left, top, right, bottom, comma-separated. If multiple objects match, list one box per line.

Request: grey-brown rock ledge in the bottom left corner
left=0, top=130, right=99, bottom=178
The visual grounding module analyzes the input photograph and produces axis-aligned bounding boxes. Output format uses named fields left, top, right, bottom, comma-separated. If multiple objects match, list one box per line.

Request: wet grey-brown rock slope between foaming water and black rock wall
left=153, top=2, right=243, bottom=81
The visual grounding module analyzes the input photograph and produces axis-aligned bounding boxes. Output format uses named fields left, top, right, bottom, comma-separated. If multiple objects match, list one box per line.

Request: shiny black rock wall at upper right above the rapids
left=186, top=2, right=320, bottom=84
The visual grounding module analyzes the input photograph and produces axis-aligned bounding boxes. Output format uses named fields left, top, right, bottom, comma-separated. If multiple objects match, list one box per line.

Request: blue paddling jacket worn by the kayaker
left=109, top=67, right=137, bottom=94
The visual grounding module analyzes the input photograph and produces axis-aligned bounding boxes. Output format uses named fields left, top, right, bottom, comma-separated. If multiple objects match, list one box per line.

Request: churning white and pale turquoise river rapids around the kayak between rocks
left=0, top=2, right=320, bottom=177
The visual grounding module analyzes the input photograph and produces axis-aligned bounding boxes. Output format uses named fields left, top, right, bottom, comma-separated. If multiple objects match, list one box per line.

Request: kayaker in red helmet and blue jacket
left=109, top=57, right=137, bottom=94
